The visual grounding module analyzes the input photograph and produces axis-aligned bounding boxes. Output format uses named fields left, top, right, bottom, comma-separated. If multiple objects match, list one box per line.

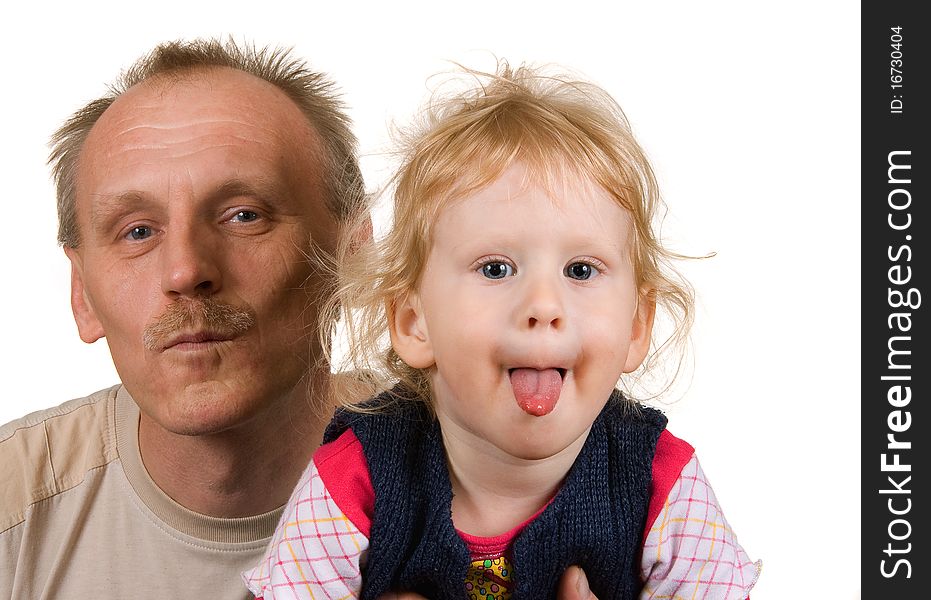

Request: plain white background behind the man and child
left=0, top=0, right=860, bottom=600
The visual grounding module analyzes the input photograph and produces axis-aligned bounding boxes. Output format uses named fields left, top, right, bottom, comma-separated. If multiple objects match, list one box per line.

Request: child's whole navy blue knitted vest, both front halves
left=324, top=388, right=666, bottom=600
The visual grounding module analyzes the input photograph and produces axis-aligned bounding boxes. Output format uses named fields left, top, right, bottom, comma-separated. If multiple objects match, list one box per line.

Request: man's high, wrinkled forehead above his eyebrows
left=78, top=68, right=320, bottom=185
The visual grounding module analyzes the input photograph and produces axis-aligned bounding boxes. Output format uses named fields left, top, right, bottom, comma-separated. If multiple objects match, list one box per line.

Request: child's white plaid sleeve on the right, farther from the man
left=640, top=456, right=762, bottom=600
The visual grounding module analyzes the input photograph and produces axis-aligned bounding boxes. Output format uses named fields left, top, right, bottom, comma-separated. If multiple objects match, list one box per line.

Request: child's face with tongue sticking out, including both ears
left=391, top=163, right=653, bottom=459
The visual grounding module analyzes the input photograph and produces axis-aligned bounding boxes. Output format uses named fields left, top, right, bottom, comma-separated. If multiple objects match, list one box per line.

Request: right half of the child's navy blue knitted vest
left=511, top=392, right=666, bottom=600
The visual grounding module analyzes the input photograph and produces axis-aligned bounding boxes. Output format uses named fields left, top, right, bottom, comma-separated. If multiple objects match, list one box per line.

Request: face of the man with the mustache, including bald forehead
left=67, top=69, right=335, bottom=435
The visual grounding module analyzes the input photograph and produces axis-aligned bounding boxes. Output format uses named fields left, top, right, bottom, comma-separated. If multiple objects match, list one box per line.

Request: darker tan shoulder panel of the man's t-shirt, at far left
left=0, top=385, right=120, bottom=532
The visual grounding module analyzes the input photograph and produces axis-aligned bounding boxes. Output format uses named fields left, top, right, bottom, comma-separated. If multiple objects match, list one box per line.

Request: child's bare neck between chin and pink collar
left=443, top=420, right=588, bottom=537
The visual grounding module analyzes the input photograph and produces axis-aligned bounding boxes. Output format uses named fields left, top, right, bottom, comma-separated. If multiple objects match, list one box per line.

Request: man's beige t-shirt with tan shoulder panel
left=0, top=386, right=281, bottom=600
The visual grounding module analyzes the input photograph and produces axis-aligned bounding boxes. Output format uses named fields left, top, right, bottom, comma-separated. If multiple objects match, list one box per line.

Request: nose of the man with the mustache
left=161, top=224, right=221, bottom=298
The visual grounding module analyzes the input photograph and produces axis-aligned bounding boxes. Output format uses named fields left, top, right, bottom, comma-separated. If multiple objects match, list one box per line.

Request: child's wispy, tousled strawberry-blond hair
left=330, top=61, right=694, bottom=400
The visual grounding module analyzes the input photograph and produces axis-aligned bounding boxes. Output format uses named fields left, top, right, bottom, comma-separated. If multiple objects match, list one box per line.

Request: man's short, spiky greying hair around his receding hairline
left=49, top=39, right=364, bottom=248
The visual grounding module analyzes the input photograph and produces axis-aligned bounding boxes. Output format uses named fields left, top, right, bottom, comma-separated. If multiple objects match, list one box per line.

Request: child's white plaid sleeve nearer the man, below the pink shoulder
left=242, top=454, right=369, bottom=600
